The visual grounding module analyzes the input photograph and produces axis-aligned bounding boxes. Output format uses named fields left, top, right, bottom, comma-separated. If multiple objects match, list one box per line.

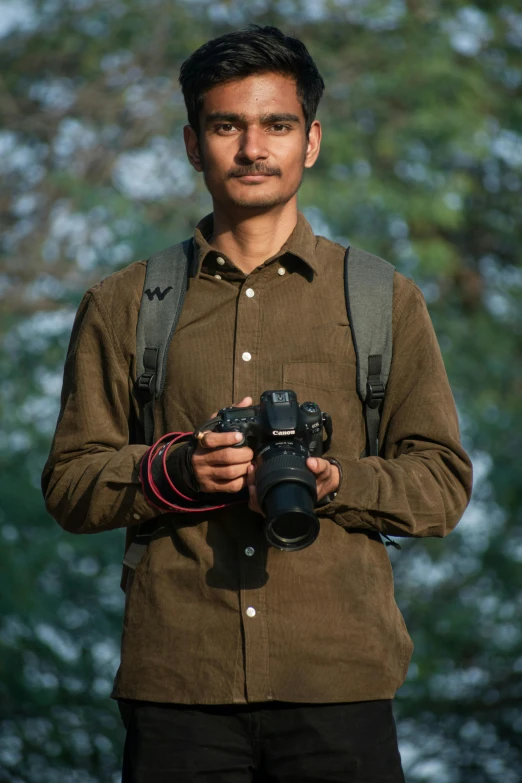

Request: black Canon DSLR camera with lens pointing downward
left=203, top=389, right=332, bottom=551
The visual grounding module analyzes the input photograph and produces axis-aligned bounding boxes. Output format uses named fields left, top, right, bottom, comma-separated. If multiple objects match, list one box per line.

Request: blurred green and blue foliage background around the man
left=0, top=0, right=522, bottom=783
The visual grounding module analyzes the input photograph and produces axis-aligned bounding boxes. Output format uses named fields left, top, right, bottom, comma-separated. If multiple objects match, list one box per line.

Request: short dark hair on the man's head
left=179, top=25, right=324, bottom=135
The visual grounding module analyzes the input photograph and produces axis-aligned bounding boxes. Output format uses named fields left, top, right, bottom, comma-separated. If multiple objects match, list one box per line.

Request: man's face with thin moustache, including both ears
left=185, top=73, right=321, bottom=209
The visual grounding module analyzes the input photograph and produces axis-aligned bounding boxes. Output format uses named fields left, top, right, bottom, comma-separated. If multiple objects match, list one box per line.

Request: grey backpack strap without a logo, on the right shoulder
left=344, top=247, right=395, bottom=456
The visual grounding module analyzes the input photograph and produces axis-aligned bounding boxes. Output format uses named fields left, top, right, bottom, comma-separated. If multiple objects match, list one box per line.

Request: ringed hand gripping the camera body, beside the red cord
left=192, top=397, right=254, bottom=492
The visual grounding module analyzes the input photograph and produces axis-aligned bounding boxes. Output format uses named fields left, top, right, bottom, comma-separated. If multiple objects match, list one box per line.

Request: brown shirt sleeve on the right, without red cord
left=320, top=278, right=472, bottom=537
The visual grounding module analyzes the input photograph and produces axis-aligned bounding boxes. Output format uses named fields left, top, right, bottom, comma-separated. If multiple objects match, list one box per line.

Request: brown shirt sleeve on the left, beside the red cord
left=42, top=291, right=180, bottom=533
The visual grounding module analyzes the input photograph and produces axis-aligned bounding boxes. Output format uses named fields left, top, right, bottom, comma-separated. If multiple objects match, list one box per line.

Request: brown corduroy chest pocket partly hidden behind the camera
left=281, top=362, right=366, bottom=459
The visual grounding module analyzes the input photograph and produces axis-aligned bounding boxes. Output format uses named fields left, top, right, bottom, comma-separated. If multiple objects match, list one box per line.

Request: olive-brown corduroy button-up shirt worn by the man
left=42, top=214, right=472, bottom=704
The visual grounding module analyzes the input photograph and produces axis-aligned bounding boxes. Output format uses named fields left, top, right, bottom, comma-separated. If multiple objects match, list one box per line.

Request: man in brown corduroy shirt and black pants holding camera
left=43, top=27, right=471, bottom=783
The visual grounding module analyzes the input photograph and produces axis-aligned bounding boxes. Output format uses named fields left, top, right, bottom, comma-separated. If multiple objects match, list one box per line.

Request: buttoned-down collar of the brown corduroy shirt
left=194, top=212, right=319, bottom=277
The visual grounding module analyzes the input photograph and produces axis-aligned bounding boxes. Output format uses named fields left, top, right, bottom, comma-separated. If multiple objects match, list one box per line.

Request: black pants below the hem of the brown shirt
left=122, top=700, right=404, bottom=783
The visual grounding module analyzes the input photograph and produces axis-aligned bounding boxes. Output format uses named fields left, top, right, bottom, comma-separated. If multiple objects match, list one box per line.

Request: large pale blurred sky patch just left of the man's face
left=112, top=136, right=195, bottom=201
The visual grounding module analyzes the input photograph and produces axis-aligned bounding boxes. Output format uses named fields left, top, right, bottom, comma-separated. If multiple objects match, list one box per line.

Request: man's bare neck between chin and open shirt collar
left=210, top=199, right=297, bottom=274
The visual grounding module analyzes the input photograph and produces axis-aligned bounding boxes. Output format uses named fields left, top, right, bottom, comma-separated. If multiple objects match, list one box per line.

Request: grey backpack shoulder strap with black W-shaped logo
left=136, top=239, right=194, bottom=445
